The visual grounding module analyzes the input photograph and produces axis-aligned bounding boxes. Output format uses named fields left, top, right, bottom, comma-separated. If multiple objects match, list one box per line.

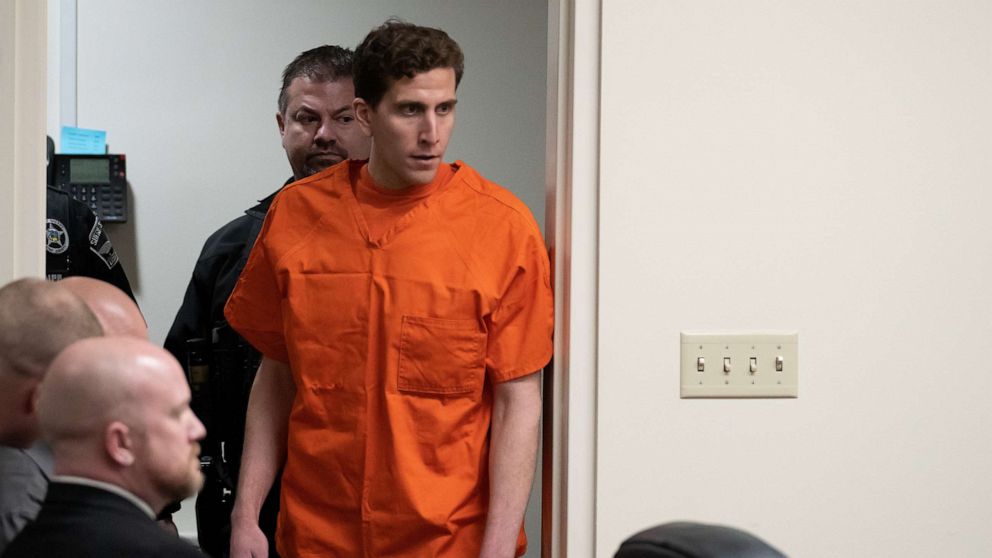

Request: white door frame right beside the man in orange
left=542, top=0, right=602, bottom=558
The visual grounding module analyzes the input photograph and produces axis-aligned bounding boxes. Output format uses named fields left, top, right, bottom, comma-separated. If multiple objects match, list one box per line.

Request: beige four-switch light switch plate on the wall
left=680, top=331, right=799, bottom=399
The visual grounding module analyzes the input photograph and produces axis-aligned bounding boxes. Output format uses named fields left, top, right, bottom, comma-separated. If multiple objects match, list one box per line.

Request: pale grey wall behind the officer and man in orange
left=76, top=0, right=547, bottom=555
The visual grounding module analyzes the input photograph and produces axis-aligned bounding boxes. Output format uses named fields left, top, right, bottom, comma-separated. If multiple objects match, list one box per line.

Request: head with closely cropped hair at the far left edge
left=0, top=279, right=103, bottom=447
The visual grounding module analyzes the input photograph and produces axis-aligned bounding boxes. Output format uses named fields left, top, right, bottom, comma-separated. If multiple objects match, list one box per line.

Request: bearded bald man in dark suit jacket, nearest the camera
left=3, top=337, right=206, bottom=558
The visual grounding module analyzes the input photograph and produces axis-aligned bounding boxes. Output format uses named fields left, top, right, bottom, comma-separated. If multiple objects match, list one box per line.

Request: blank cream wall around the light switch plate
left=597, top=0, right=992, bottom=558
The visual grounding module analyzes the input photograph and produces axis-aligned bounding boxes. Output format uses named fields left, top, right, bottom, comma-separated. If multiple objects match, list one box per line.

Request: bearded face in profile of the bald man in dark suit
left=137, top=363, right=206, bottom=501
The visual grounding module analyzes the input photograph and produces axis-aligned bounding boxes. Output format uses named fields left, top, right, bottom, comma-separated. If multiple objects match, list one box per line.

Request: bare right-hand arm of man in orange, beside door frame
left=480, top=373, right=541, bottom=558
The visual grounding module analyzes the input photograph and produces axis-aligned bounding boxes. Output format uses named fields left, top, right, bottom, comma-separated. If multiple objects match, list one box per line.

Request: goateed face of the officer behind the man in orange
left=276, top=77, right=369, bottom=180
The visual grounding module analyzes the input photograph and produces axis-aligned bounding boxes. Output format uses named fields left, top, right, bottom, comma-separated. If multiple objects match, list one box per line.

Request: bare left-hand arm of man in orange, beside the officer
left=231, top=357, right=296, bottom=558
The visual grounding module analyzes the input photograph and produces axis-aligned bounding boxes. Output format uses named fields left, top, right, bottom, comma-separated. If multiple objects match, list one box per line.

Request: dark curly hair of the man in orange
left=353, top=18, right=465, bottom=108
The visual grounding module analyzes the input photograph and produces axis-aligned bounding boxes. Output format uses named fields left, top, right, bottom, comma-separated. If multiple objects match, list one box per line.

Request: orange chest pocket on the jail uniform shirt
left=397, top=316, right=486, bottom=396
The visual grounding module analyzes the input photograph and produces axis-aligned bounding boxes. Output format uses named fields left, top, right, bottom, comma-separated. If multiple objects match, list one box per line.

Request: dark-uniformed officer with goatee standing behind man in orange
left=165, top=45, right=369, bottom=557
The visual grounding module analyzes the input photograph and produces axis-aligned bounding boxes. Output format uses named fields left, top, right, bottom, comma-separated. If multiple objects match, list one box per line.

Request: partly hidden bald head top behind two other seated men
left=59, top=277, right=148, bottom=339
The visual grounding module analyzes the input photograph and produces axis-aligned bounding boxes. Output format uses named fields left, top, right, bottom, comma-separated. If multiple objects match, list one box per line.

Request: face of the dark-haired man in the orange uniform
left=355, top=68, right=457, bottom=189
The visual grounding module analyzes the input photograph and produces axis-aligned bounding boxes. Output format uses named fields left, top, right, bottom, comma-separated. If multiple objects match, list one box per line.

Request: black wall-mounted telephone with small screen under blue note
left=51, top=153, right=128, bottom=223
